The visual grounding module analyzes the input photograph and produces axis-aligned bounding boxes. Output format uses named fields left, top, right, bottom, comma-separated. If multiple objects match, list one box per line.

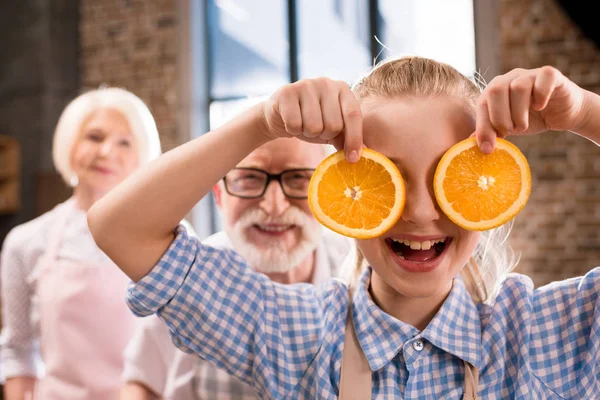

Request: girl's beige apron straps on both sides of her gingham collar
left=338, top=286, right=479, bottom=400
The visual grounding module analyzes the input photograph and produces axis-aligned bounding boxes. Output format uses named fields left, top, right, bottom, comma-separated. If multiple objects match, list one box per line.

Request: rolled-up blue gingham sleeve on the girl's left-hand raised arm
left=127, top=227, right=345, bottom=398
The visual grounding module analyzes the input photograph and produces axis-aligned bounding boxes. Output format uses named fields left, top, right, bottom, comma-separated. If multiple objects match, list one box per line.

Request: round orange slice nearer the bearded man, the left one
left=308, top=149, right=406, bottom=239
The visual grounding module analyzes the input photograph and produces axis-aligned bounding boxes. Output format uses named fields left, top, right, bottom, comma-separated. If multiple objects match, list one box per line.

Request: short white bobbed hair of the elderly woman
left=52, top=87, right=161, bottom=185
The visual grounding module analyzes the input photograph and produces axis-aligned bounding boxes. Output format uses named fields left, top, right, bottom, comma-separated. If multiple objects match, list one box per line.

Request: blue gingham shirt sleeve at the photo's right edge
left=530, top=268, right=600, bottom=398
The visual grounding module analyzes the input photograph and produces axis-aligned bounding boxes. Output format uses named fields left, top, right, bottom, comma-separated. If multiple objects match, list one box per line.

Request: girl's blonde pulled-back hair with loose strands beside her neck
left=341, top=56, right=517, bottom=303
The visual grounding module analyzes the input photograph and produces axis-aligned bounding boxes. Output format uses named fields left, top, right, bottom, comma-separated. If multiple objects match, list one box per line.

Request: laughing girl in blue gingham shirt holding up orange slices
left=88, top=57, right=600, bottom=399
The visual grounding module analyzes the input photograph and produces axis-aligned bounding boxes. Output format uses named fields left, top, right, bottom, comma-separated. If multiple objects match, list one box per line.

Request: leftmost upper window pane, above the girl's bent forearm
left=207, top=0, right=290, bottom=99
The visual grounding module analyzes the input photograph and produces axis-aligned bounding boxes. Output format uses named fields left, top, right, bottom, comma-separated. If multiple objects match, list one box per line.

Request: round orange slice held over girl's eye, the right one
left=433, top=137, right=531, bottom=231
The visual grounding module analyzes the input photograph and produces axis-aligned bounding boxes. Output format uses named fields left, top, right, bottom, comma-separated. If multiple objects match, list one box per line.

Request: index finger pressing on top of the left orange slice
left=339, top=87, right=363, bottom=163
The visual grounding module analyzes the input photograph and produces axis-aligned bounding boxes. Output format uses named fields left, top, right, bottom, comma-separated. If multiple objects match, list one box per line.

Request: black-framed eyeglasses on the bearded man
left=223, top=168, right=315, bottom=199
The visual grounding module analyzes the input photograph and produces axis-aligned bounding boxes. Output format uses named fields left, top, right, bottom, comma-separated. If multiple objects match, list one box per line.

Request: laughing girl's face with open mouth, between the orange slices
left=358, top=97, right=479, bottom=299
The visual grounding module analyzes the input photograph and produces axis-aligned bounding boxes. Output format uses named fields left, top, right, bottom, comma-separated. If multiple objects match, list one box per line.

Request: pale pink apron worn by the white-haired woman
left=35, top=208, right=136, bottom=400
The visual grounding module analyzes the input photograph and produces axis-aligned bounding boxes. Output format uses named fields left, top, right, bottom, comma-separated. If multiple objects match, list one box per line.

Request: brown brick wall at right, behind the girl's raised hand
left=500, top=0, right=600, bottom=285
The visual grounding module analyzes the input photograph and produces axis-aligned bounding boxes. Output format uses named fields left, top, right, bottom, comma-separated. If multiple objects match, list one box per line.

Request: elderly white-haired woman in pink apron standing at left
left=1, top=88, right=161, bottom=400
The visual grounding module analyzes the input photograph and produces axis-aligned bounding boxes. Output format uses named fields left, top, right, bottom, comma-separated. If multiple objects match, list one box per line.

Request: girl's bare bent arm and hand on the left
left=88, top=78, right=362, bottom=281
